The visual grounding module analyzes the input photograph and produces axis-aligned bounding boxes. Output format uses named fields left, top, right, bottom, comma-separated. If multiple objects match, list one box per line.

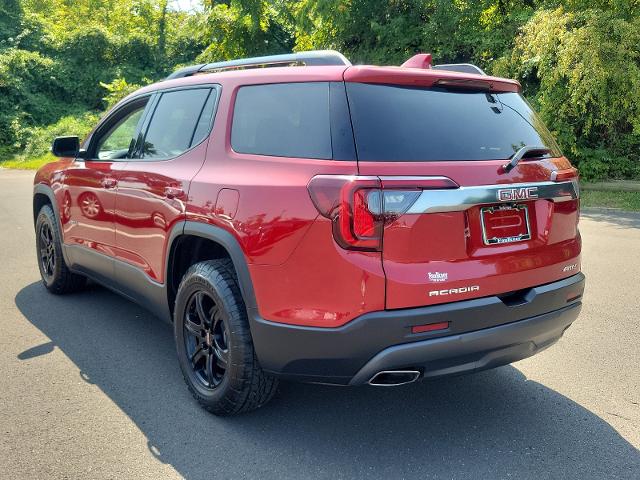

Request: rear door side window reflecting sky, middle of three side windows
left=142, top=88, right=216, bottom=160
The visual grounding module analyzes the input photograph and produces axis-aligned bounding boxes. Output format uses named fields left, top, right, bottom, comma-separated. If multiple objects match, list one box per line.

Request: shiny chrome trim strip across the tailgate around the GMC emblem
left=406, top=181, right=578, bottom=214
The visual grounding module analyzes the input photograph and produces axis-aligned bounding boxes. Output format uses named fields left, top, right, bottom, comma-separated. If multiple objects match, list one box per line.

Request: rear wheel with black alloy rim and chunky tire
left=174, top=259, right=278, bottom=416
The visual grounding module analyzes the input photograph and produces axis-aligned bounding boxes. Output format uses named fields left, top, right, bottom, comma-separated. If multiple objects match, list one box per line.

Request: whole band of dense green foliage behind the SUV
left=0, top=0, right=640, bottom=178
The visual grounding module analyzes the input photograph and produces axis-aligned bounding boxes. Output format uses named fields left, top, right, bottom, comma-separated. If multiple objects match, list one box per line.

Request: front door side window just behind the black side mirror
left=95, top=99, right=147, bottom=160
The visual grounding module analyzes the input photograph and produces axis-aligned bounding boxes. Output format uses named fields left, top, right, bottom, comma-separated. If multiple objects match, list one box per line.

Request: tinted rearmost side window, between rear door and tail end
left=231, top=82, right=332, bottom=159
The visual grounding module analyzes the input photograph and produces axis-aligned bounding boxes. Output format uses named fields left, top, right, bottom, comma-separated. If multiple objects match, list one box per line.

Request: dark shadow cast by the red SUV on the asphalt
left=15, top=283, right=640, bottom=479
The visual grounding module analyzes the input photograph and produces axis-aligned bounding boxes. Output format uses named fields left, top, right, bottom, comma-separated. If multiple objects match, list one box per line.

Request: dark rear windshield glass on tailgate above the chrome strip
left=347, top=83, right=560, bottom=162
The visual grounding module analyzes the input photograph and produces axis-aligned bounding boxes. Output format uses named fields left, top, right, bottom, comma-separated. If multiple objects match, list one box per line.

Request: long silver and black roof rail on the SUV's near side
left=165, top=50, right=351, bottom=80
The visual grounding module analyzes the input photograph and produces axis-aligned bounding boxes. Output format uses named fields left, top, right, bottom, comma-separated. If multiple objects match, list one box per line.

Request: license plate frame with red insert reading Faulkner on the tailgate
left=480, top=204, right=531, bottom=245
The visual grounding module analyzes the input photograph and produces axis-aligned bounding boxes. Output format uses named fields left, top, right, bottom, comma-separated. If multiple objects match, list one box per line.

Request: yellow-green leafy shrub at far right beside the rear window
left=493, top=8, right=640, bottom=179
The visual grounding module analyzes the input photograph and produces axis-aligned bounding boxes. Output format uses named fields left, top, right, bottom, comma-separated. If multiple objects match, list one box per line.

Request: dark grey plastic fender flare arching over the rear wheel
left=165, top=220, right=258, bottom=317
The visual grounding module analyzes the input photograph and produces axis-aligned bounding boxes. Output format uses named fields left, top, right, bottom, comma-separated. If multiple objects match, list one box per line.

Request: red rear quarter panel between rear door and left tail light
left=187, top=74, right=384, bottom=327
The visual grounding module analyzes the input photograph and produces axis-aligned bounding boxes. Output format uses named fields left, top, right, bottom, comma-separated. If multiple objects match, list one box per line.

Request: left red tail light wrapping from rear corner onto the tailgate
left=308, top=175, right=458, bottom=252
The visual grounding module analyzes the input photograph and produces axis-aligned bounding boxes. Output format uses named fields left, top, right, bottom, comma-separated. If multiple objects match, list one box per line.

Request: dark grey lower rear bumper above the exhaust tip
left=251, top=273, right=584, bottom=385
